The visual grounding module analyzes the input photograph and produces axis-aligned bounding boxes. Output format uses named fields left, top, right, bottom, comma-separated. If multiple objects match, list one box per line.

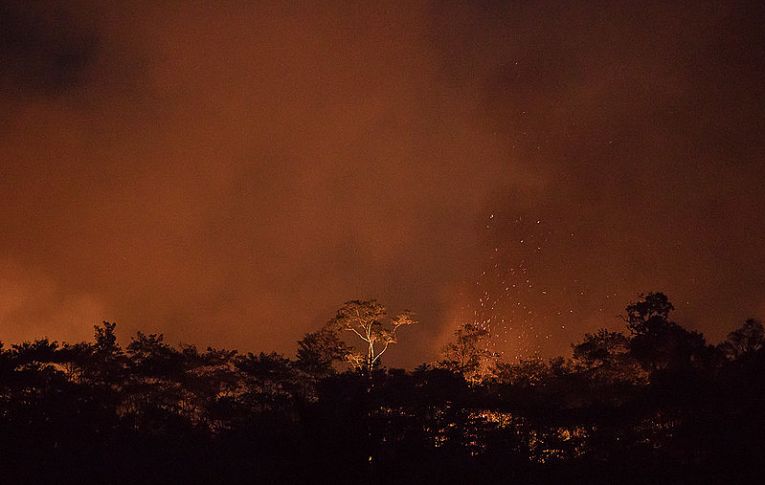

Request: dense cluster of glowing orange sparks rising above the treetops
left=458, top=214, right=627, bottom=362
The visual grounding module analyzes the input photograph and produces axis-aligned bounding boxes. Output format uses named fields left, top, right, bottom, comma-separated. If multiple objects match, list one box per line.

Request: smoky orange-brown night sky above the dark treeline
left=0, top=0, right=765, bottom=366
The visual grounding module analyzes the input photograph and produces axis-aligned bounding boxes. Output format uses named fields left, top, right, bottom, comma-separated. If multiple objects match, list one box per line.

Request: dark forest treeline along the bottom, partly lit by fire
left=0, top=293, right=765, bottom=484
